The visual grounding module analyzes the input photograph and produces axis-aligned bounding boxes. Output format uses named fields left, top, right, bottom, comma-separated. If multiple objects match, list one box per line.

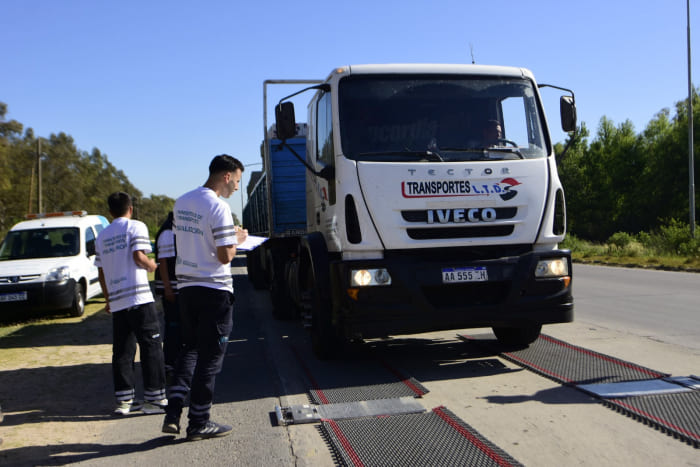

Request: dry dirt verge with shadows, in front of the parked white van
left=0, top=298, right=124, bottom=465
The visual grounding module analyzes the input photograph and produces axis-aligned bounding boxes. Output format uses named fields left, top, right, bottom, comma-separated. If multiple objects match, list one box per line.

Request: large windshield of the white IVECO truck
left=338, top=75, right=548, bottom=162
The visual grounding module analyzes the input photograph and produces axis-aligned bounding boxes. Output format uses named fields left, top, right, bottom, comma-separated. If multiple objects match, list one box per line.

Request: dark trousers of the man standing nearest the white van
left=112, top=303, right=165, bottom=401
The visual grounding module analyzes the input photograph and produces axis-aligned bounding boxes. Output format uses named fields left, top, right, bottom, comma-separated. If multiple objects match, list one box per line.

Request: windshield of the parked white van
left=0, top=227, right=80, bottom=261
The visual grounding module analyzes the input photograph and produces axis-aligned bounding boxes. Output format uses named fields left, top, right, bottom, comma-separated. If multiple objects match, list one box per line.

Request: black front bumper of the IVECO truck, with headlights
left=331, top=250, right=573, bottom=338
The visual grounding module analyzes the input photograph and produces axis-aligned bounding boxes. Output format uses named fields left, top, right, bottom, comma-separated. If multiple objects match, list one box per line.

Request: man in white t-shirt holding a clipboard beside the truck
left=162, top=154, right=248, bottom=440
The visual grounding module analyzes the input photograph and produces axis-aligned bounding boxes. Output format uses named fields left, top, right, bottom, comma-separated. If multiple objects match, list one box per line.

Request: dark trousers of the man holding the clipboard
left=167, top=286, right=233, bottom=426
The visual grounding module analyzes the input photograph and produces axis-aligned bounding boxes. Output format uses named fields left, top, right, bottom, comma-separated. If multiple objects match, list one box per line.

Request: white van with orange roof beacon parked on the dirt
left=0, top=211, right=109, bottom=316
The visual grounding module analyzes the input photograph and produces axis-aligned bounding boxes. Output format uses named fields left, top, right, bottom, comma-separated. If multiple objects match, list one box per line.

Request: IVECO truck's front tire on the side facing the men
left=304, top=233, right=345, bottom=360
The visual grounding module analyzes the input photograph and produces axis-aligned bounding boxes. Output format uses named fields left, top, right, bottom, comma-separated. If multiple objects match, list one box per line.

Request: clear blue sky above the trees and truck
left=0, top=0, right=700, bottom=220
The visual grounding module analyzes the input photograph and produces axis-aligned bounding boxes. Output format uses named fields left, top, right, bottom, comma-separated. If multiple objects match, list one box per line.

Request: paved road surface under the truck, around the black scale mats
left=61, top=265, right=700, bottom=466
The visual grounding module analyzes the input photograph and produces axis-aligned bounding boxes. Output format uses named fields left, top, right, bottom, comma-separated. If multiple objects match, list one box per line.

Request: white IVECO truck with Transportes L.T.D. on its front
left=249, top=64, right=576, bottom=358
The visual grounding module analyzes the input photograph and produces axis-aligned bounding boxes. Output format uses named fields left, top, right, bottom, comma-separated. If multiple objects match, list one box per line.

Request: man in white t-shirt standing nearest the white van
left=95, top=192, right=168, bottom=415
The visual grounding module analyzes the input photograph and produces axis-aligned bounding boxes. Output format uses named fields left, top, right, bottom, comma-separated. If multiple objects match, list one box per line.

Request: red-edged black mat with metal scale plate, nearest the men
left=275, top=378, right=521, bottom=467
